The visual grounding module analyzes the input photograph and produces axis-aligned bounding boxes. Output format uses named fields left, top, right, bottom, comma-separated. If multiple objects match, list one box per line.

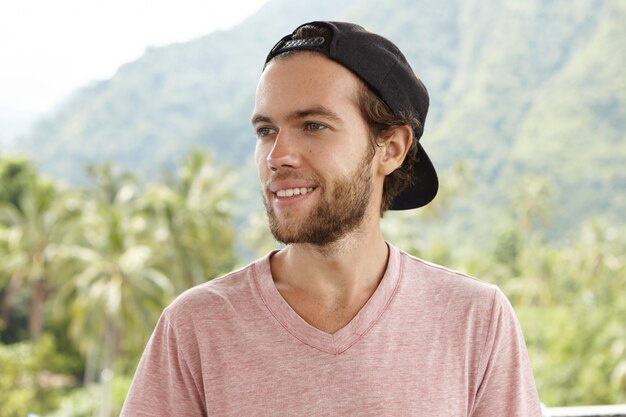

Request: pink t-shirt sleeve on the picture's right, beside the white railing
left=470, top=289, right=542, bottom=417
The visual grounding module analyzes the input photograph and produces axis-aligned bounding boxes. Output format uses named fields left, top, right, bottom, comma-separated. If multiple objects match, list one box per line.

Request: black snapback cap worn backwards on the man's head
left=265, top=21, right=439, bottom=210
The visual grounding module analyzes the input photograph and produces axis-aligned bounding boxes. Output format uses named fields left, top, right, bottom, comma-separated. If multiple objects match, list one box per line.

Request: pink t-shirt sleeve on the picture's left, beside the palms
left=120, top=313, right=207, bottom=417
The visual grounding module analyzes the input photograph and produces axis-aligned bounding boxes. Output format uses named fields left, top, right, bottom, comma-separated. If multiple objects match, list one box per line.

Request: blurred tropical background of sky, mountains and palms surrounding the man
left=0, top=0, right=626, bottom=417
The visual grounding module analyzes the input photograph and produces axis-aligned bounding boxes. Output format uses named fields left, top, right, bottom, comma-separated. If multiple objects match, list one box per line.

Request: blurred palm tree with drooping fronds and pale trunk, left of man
left=59, top=165, right=173, bottom=416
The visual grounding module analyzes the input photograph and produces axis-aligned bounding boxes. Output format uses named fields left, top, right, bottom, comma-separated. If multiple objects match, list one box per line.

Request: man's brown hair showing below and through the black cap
left=279, top=25, right=423, bottom=216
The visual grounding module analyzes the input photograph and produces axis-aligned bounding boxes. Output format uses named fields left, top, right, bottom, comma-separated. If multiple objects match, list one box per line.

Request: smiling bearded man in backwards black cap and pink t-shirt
left=122, top=22, right=541, bottom=417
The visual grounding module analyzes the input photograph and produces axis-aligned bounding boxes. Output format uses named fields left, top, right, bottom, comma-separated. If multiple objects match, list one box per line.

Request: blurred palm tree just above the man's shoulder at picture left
left=142, top=151, right=235, bottom=292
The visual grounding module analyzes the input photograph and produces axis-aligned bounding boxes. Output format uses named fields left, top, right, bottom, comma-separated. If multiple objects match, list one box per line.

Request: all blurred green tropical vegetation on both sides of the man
left=0, top=151, right=626, bottom=417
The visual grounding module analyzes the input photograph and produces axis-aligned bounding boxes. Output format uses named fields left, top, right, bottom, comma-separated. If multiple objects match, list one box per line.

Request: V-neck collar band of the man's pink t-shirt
left=253, top=243, right=401, bottom=355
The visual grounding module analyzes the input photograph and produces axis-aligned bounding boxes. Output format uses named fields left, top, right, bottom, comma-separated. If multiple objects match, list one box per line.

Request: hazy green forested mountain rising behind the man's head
left=13, top=0, right=626, bottom=237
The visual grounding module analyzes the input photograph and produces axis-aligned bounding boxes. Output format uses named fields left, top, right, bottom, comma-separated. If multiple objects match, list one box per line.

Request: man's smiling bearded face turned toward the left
left=252, top=52, right=377, bottom=245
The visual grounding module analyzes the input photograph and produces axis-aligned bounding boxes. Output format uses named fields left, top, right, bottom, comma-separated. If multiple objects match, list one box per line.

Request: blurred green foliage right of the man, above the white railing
left=460, top=202, right=626, bottom=406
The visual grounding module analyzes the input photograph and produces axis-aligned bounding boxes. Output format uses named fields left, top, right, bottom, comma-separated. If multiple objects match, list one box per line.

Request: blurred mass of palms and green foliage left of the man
left=0, top=151, right=235, bottom=416
